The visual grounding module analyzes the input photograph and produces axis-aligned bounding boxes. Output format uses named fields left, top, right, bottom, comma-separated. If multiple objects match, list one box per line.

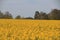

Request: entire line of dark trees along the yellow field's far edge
left=0, top=9, right=60, bottom=20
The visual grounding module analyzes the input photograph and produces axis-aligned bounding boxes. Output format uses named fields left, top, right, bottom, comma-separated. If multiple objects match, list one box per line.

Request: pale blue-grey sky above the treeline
left=0, top=0, right=60, bottom=17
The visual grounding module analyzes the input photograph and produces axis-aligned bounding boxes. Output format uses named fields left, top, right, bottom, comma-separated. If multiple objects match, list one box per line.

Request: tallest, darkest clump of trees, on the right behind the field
left=34, top=9, right=60, bottom=20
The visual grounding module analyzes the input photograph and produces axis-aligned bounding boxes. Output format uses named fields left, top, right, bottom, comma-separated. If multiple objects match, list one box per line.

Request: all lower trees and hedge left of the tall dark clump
left=0, top=11, right=33, bottom=19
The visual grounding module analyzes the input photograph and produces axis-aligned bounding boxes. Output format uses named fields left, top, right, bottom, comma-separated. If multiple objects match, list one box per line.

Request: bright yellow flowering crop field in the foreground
left=0, top=19, right=60, bottom=40
